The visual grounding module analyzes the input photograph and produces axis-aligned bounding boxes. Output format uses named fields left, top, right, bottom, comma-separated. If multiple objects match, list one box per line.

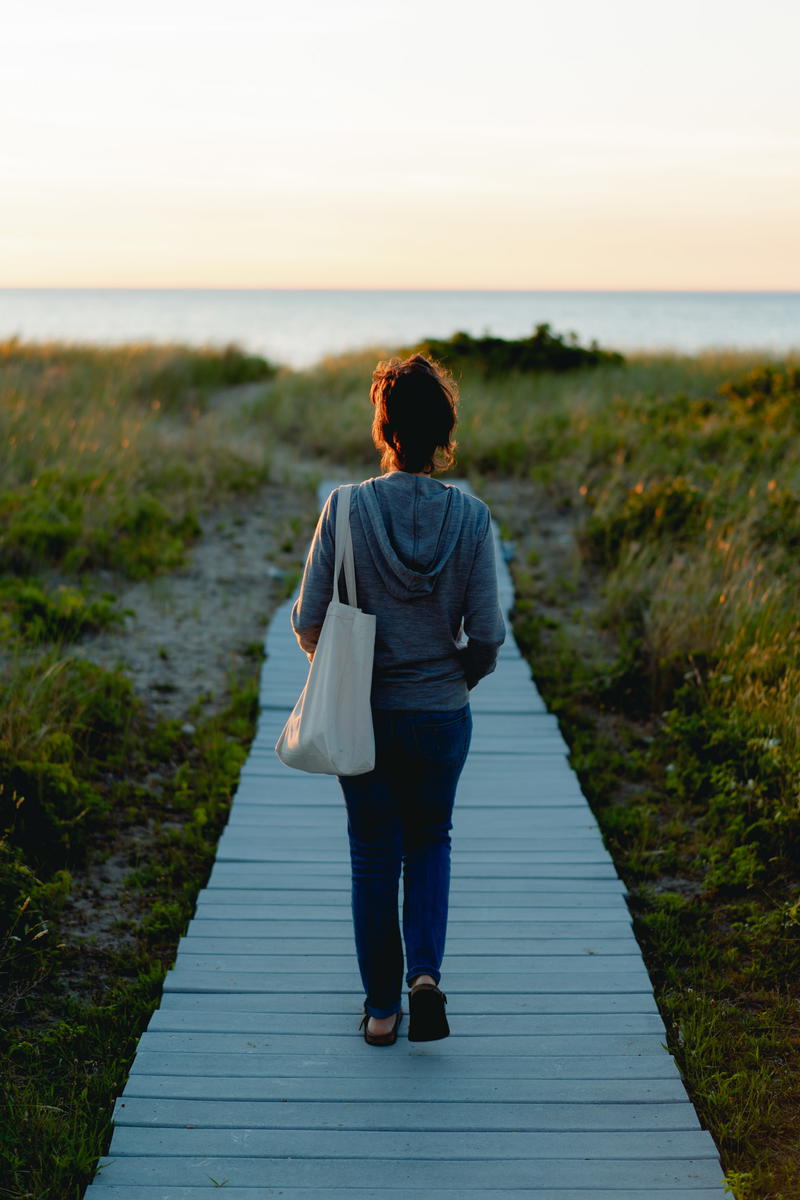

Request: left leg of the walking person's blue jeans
left=339, top=713, right=403, bottom=1016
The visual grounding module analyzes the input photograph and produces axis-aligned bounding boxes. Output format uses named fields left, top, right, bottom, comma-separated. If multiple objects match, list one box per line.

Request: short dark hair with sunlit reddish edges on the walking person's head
left=369, top=354, right=458, bottom=473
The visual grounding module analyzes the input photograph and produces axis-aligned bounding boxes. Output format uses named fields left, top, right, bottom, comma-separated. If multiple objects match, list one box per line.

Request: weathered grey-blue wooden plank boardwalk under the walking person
left=86, top=482, right=723, bottom=1200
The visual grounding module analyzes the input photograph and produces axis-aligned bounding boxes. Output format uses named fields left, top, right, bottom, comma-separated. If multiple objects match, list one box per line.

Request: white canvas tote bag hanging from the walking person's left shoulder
left=275, top=487, right=375, bottom=775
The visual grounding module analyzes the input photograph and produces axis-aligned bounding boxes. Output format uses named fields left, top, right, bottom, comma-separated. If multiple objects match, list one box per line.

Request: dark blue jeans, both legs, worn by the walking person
left=339, top=704, right=473, bottom=1016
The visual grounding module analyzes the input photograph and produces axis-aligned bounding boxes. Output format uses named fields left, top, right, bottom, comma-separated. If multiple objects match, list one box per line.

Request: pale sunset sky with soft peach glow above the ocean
left=0, top=0, right=800, bottom=290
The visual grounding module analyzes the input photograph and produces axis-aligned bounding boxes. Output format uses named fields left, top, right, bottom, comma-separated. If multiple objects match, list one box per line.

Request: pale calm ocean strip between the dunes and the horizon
left=0, top=288, right=800, bottom=367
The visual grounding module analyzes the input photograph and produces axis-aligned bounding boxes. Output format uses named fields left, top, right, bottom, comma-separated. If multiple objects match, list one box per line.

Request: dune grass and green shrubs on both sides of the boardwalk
left=0, top=331, right=800, bottom=1200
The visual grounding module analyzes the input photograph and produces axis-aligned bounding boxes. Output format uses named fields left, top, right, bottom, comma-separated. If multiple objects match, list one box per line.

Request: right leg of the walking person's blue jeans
left=403, top=706, right=473, bottom=984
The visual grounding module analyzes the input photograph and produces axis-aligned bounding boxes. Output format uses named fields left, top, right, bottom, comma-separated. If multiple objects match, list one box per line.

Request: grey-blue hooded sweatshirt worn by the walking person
left=291, top=470, right=505, bottom=710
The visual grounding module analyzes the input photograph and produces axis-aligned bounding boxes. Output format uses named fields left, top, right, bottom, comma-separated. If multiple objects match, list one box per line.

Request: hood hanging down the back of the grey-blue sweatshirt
left=354, top=470, right=464, bottom=600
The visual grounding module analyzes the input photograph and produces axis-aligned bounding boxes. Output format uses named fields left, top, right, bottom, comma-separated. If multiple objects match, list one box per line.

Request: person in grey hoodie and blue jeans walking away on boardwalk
left=291, top=354, right=505, bottom=1045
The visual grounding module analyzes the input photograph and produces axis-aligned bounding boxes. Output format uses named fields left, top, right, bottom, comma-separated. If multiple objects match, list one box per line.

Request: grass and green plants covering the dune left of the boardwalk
left=0, top=342, right=313, bottom=1200
